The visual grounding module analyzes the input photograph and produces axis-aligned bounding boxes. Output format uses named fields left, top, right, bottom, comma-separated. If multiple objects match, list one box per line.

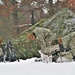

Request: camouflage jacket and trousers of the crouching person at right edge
left=52, top=32, right=75, bottom=60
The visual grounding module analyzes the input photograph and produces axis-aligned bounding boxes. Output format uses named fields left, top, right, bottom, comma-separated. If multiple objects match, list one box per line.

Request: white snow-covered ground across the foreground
left=0, top=58, right=75, bottom=75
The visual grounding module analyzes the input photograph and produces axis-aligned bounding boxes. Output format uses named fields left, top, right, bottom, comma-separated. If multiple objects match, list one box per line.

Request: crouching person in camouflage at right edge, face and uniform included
left=52, top=32, right=75, bottom=61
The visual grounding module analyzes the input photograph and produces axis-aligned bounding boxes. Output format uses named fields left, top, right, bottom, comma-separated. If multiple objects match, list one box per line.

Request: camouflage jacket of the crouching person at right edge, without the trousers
left=63, top=32, right=75, bottom=56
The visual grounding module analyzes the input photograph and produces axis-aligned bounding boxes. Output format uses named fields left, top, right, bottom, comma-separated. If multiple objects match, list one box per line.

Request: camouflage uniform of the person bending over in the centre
left=33, top=27, right=59, bottom=55
